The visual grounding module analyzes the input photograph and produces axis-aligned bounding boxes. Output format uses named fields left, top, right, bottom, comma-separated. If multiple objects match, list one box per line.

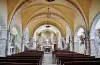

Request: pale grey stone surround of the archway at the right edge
left=90, top=12, right=100, bottom=57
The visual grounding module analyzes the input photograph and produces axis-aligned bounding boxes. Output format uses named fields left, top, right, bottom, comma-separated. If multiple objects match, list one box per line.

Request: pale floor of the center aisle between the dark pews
left=42, top=53, right=57, bottom=65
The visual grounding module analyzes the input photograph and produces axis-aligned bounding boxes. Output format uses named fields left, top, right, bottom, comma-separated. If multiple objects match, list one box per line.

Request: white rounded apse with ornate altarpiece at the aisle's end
left=33, top=25, right=62, bottom=51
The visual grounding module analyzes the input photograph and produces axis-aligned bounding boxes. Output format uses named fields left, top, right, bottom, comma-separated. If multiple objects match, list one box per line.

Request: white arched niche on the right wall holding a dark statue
left=74, top=27, right=86, bottom=54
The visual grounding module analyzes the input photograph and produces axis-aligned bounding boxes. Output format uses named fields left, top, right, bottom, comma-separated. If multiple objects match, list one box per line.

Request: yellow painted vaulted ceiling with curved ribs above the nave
left=7, top=0, right=91, bottom=35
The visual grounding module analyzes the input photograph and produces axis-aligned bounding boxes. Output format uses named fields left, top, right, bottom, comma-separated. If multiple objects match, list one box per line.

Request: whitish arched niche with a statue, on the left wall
left=8, top=25, right=22, bottom=55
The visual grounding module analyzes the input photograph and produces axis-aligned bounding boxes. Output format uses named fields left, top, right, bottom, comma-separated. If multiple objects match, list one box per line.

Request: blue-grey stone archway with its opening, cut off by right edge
left=90, top=13, right=100, bottom=57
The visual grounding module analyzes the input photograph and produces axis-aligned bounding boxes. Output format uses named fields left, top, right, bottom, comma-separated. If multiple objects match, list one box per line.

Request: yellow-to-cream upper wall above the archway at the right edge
left=89, top=0, right=100, bottom=28
